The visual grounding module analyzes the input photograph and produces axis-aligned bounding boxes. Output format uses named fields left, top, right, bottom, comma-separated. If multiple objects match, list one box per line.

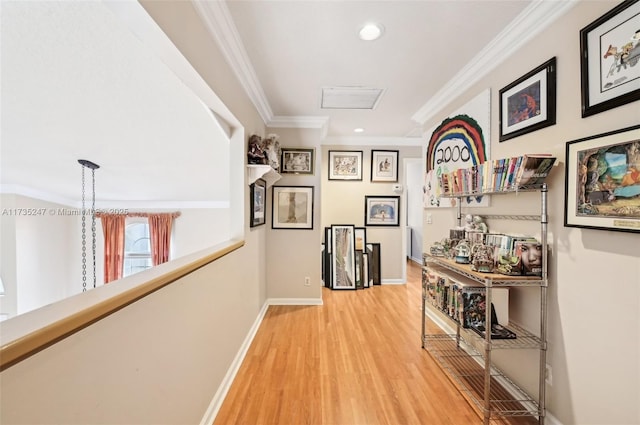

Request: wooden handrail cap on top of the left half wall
left=0, top=240, right=244, bottom=371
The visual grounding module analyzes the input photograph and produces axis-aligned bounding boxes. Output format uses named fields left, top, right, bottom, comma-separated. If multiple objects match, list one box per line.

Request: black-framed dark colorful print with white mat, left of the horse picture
left=500, top=57, right=556, bottom=142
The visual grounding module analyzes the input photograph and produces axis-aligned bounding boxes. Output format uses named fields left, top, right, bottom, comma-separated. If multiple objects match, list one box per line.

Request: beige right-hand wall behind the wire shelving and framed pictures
left=424, top=1, right=640, bottom=425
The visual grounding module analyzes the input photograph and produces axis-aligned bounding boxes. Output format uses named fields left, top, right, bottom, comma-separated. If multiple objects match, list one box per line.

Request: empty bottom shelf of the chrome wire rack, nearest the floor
left=423, top=334, right=540, bottom=417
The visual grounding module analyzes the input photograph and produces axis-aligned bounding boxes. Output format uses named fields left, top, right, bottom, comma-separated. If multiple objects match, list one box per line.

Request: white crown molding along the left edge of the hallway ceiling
left=191, top=0, right=273, bottom=124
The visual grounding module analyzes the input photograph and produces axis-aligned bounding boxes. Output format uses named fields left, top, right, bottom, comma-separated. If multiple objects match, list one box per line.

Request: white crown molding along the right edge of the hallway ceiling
left=411, top=0, right=578, bottom=124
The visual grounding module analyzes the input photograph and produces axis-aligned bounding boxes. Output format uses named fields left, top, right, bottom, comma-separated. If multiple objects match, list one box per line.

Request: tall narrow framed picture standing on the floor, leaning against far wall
left=331, top=224, right=356, bottom=290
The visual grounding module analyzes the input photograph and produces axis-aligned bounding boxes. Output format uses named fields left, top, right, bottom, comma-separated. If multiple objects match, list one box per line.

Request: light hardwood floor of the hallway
left=215, top=261, right=537, bottom=425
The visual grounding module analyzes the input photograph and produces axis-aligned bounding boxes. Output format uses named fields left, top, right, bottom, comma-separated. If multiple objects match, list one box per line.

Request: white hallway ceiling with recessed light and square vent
left=219, top=0, right=531, bottom=138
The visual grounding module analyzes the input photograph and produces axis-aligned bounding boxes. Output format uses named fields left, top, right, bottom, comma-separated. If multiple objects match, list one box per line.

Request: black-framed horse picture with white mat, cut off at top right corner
left=580, top=0, right=640, bottom=118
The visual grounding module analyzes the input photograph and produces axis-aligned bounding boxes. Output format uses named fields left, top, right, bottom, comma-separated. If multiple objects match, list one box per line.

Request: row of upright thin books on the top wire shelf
left=438, top=154, right=556, bottom=195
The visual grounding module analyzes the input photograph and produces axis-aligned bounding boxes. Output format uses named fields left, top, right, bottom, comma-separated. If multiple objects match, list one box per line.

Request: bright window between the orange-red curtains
left=122, top=218, right=153, bottom=277
